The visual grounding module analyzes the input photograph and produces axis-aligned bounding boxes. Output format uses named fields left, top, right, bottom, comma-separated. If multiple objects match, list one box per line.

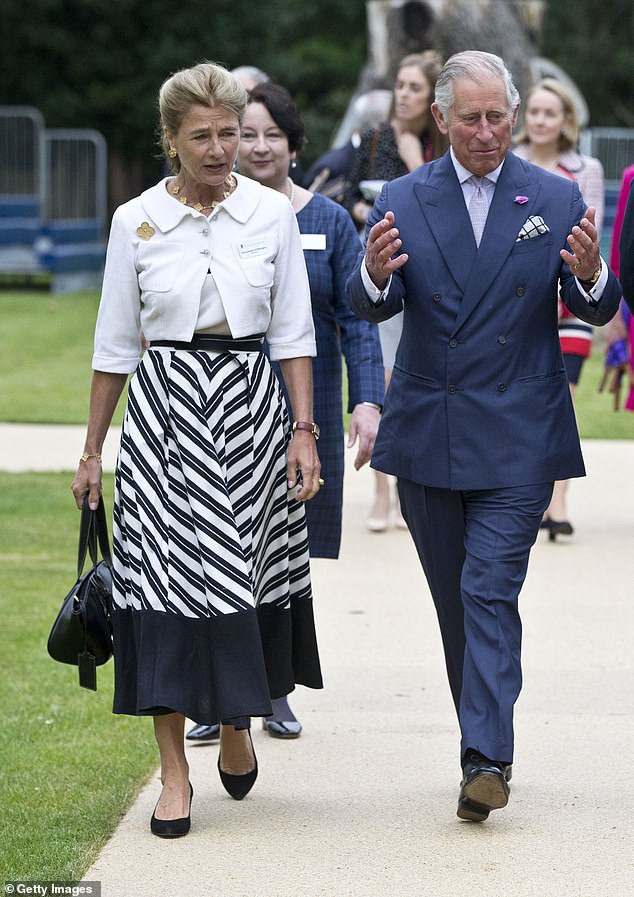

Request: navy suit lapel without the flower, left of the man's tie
left=414, top=153, right=476, bottom=291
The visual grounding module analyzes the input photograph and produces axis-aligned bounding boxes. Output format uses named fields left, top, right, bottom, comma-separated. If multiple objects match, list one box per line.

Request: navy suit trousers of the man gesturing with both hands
left=398, top=479, right=553, bottom=763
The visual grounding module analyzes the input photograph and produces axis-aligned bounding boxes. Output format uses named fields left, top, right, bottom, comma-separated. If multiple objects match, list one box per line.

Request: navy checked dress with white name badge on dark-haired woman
left=272, top=194, right=384, bottom=558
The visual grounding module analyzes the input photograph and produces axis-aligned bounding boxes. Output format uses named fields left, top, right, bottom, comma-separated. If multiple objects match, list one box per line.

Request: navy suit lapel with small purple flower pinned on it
left=454, top=153, right=540, bottom=333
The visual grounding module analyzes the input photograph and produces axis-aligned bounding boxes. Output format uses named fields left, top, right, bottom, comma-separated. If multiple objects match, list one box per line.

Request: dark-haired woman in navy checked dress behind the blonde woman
left=188, top=83, right=383, bottom=739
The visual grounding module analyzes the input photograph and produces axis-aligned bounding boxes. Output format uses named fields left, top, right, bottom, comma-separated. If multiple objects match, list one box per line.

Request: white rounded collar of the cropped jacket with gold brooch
left=141, top=172, right=264, bottom=233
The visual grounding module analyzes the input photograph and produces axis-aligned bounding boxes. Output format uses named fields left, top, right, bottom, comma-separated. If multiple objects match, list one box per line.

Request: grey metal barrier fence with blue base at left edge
left=0, top=106, right=107, bottom=292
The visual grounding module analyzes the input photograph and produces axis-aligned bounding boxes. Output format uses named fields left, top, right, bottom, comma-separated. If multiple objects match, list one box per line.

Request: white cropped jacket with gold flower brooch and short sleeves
left=92, top=175, right=316, bottom=374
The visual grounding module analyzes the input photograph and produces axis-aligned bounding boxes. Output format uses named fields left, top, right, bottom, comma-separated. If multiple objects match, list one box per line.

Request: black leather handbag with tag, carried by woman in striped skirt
left=47, top=496, right=113, bottom=691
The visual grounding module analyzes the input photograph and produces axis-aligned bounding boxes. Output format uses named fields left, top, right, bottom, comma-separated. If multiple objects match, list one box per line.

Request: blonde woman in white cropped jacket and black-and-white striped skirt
left=72, top=63, right=322, bottom=838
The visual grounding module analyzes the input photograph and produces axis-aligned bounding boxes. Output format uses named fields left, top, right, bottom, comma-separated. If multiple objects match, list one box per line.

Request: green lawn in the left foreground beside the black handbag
left=0, top=473, right=157, bottom=881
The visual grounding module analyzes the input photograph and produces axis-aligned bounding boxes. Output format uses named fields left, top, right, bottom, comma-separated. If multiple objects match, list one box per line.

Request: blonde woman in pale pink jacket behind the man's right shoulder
left=514, top=78, right=605, bottom=542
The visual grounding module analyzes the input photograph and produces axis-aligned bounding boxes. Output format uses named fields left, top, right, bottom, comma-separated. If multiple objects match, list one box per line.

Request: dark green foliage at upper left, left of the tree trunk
left=0, top=0, right=366, bottom=183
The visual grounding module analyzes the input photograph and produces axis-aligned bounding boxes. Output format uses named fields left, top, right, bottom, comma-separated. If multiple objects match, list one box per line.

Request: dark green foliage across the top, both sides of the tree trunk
left=0, top=0, right=634, bottom=193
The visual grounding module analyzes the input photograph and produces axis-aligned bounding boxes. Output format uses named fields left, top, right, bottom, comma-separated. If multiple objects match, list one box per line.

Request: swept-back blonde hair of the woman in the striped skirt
left=158, top=62, right=247, bottom=174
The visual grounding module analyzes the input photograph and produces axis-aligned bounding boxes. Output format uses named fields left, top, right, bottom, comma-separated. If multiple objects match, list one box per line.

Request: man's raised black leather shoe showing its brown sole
left=458, top=751, right=513, bottom=822
